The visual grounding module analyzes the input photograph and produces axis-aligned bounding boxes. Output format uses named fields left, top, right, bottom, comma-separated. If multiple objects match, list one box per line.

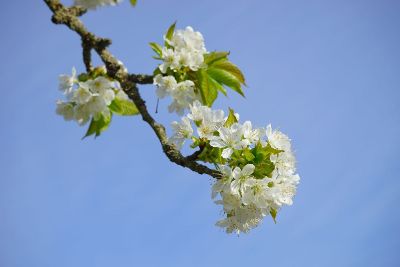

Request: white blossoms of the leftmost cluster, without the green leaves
left=56, top=68, right=126, bottom=125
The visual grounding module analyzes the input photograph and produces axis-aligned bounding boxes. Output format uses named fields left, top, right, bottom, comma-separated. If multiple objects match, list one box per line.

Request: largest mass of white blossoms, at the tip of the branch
left=170, top=101, right=300, bottom=234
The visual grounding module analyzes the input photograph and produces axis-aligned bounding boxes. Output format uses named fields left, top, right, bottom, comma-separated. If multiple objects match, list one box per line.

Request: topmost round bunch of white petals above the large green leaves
left=159, top=26, right=207, bottom=73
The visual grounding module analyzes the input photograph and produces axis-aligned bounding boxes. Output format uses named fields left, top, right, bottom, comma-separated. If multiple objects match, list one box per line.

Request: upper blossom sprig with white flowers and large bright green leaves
left=150, top=23, right=245, bottom=114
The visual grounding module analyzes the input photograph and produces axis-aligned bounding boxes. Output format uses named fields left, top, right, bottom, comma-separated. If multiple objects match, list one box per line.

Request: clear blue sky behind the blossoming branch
left=0, top=0, right=400, bottom=267
